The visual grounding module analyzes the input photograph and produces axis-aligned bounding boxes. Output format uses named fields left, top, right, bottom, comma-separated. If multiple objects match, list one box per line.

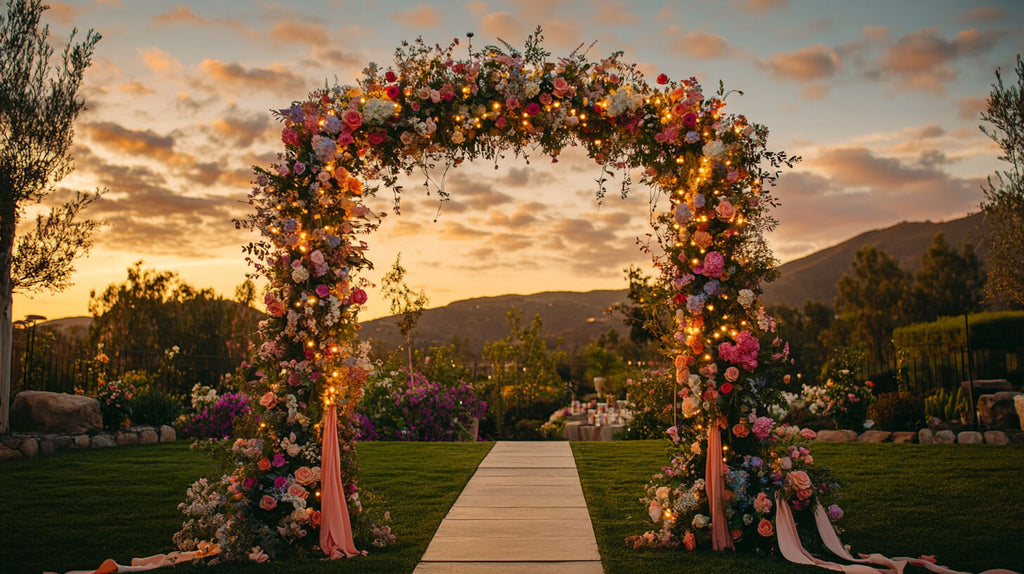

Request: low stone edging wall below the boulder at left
left=0, top=425, right=177, bottom=461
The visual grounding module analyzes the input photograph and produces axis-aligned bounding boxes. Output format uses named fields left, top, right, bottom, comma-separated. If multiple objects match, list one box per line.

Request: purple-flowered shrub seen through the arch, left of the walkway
left=359, top=372, right=487, bottom=441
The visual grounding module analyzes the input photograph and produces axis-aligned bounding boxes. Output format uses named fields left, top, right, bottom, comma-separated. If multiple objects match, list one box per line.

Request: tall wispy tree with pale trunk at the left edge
left=0, top=0, right=99, bottom=432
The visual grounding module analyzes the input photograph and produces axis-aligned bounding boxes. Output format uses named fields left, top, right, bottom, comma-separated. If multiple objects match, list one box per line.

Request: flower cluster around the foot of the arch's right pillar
left=627, top=416, right=843, bottom=550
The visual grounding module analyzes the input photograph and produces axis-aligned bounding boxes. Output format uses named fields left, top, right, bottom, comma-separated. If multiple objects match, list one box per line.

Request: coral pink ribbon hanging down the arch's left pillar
left=321, top=405, right=365, bottom=560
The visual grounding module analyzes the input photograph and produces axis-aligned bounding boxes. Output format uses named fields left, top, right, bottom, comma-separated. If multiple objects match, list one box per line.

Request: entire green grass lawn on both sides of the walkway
left=0, top=441, right=1024, bottom=574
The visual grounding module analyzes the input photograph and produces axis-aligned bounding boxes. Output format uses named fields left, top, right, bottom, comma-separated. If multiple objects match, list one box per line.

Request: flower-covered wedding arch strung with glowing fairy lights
left=176, top=31, right=831, bottom=559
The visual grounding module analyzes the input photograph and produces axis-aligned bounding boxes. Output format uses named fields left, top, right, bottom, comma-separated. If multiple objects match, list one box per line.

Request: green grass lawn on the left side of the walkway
left=0, top=442, right=492, bottom=574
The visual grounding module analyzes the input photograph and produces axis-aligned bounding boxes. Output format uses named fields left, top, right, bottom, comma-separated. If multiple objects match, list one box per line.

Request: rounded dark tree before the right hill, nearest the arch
left=836, top=246, right=910, bottom=362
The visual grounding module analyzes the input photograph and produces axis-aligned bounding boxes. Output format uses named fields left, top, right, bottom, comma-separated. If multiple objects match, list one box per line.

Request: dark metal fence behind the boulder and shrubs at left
left=11, top=336, right=240, bottom=397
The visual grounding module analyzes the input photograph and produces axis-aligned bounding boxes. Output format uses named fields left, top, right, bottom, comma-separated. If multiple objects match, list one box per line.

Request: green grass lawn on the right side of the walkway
left=572, top=441, right=1024, bottom=574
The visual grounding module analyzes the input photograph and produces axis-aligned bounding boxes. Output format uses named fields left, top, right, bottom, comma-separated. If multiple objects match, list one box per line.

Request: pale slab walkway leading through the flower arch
left=414, top=441, right=602, bottom=574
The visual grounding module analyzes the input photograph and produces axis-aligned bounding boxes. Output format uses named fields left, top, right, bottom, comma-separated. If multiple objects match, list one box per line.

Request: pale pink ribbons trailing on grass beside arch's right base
left=775, top=494, right=1017, bottom=574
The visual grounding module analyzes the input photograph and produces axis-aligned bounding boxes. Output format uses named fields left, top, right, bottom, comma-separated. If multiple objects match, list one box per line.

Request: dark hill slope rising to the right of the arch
left=764, top=213, right=986, bottom=307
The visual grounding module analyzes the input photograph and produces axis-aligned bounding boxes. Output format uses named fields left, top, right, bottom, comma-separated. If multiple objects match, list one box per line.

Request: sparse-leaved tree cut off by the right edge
left=979, top=54, right=1024, bottom=307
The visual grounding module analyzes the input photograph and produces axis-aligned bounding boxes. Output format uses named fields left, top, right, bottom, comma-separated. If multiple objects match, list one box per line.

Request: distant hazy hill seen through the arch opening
left=359, top=290, right=628, bottom=355
